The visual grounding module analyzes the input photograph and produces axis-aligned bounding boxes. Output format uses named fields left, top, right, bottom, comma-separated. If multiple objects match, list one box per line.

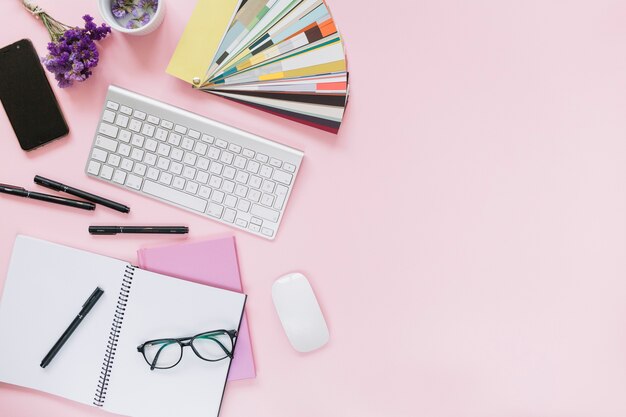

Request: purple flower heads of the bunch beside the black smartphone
left=42, top=15, right=111, bottom=88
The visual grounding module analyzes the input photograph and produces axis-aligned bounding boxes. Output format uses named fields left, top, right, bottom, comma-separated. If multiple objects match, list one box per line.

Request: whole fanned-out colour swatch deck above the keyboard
left=167, top=0, right=348, bottom=133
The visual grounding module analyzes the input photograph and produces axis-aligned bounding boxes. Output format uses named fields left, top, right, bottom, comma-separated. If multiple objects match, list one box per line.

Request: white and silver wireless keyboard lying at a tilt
left=85, top=86, right=304, bottom=239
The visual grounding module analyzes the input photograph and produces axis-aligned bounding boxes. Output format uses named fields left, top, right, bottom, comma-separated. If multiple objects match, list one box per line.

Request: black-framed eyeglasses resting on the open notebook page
left=137, top=330, right=237, bottom=371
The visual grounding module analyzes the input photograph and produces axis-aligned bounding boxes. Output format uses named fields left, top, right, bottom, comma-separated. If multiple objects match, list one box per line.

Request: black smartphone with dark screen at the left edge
left=0, top=39, right=69, bottom=151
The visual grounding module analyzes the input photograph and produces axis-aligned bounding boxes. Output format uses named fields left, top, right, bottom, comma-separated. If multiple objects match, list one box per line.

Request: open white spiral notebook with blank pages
left=0, top=236, right=246, bottom=417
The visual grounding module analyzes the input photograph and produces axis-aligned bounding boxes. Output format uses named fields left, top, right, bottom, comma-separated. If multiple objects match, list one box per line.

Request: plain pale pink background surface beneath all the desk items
left=0, top=0, right=626, bottom=417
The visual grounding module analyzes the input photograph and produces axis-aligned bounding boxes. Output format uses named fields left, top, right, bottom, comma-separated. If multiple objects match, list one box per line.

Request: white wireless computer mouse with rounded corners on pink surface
left=272, top=272, right=328, bottom=352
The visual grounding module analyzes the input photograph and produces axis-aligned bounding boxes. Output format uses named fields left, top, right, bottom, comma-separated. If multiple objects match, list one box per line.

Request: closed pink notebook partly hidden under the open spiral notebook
left=137, top=236, right=256, bottom=380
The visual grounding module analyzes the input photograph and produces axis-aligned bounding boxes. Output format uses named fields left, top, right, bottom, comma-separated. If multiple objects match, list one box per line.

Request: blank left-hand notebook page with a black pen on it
left=0, top=236, right=127, bottom=405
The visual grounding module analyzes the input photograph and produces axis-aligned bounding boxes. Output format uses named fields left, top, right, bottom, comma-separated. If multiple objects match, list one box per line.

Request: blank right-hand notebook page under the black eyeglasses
left=104, top=269, right=246, bottom=417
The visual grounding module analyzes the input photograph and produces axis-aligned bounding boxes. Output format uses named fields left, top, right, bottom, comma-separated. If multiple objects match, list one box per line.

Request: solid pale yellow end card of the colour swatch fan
left=165, top=0, right=240, bottom=85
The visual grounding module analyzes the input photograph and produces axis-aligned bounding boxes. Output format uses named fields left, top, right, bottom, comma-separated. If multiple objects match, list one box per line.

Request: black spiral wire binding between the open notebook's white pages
left=93, top=265, right=135, bottom=407
